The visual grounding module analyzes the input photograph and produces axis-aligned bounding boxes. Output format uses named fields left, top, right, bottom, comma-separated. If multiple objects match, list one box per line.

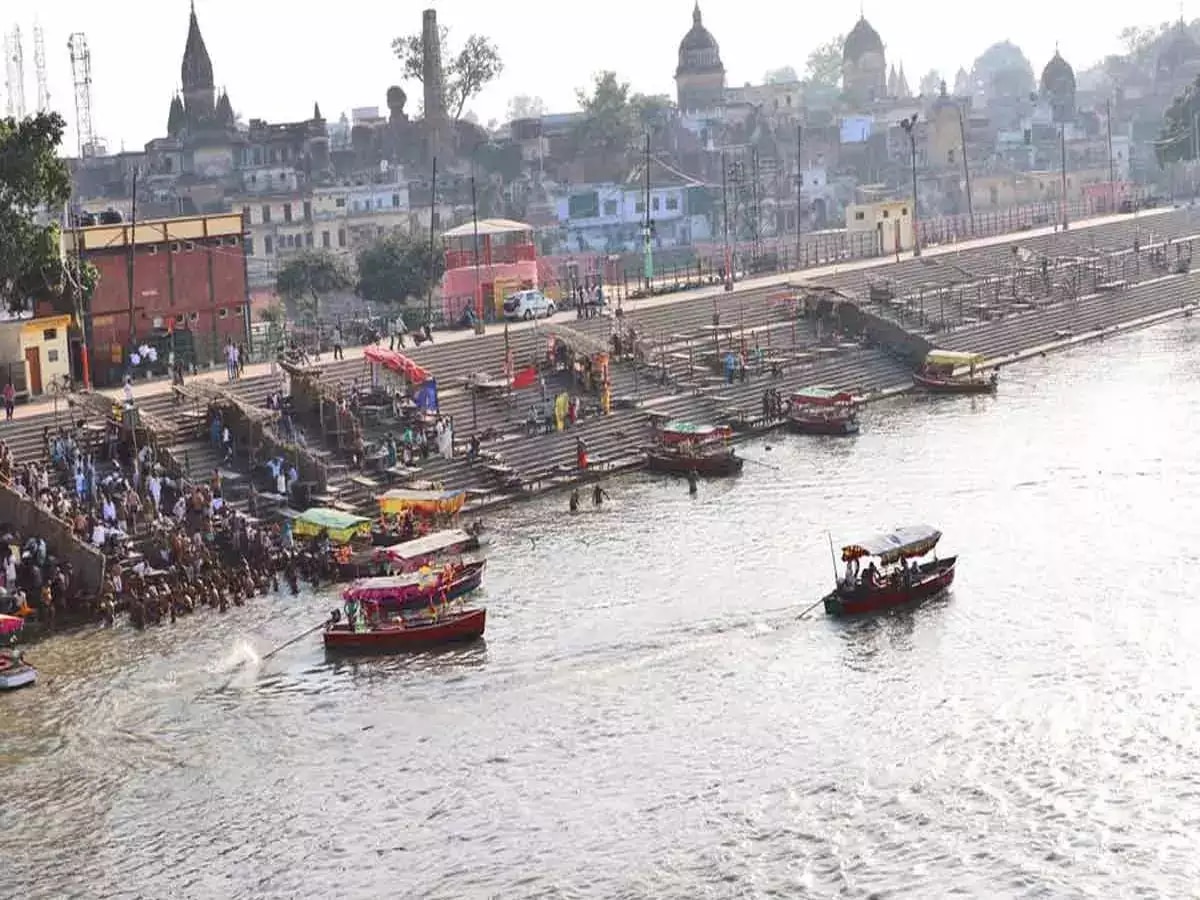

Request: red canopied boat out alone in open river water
left=823, top=526, right=958, bottom=616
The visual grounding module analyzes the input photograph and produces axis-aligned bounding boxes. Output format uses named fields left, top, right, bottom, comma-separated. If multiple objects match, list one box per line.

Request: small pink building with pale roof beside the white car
left=442, top=218, right=539, bottom=322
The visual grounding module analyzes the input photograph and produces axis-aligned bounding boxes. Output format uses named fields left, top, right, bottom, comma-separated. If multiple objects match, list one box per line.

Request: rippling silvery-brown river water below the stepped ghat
left=0, top=322, right=1200, bottom=900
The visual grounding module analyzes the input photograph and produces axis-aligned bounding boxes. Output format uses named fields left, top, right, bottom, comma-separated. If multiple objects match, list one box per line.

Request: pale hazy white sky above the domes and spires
left=0, top=0, right=1200, bottom=152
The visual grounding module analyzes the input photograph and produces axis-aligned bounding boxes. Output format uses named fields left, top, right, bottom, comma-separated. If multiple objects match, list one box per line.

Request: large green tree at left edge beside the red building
left=0, top=113, right=72, bottom=311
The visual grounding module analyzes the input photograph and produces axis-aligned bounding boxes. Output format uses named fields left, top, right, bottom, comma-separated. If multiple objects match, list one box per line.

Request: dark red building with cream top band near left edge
left=65, top=214, right=250, bottom=384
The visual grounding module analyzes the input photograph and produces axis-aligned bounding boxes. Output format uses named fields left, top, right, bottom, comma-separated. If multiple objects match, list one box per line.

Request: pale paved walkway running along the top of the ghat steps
left=13, top=206, right=1174, bottom=419
